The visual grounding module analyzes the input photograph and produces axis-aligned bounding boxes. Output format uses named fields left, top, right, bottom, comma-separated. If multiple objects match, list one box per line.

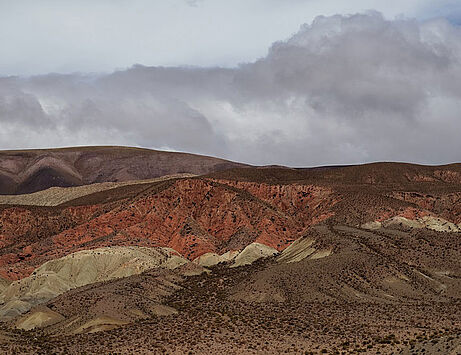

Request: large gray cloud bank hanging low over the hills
left=0, top=12, right=461, bottom=166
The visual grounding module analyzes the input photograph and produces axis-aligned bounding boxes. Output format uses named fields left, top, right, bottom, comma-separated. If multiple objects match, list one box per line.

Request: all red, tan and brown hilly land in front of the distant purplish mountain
left=0, top=155, right=461, bottom=354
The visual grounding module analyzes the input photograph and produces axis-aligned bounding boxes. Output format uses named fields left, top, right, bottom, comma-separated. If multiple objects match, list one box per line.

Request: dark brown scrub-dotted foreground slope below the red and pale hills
left=0, top=220, right=461, bottom=354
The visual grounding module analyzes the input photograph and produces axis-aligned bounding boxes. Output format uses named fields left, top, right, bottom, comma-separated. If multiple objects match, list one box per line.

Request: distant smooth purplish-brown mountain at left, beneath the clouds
left=0, top=146, right=245, bottom=194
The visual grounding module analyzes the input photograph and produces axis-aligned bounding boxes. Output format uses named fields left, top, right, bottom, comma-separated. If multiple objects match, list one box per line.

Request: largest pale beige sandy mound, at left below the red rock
left=0, top=247, right=188, bottom=320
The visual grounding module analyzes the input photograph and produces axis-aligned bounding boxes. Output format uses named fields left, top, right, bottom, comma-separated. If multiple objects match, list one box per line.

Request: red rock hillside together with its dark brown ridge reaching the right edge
left=0, top=163, right=461, bottom=279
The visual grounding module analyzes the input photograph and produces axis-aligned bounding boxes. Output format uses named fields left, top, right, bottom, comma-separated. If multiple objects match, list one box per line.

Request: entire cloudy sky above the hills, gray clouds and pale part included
left=0, top=0, right=461, bottom=166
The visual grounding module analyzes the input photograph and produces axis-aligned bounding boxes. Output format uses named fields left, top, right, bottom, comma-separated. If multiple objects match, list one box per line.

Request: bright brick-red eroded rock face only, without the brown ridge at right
left=0, top=179, right=335, bottom=279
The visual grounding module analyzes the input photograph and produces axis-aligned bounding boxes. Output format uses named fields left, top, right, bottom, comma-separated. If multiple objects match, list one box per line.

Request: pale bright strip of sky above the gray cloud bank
left=0, top=0, right=454, bottom=75
